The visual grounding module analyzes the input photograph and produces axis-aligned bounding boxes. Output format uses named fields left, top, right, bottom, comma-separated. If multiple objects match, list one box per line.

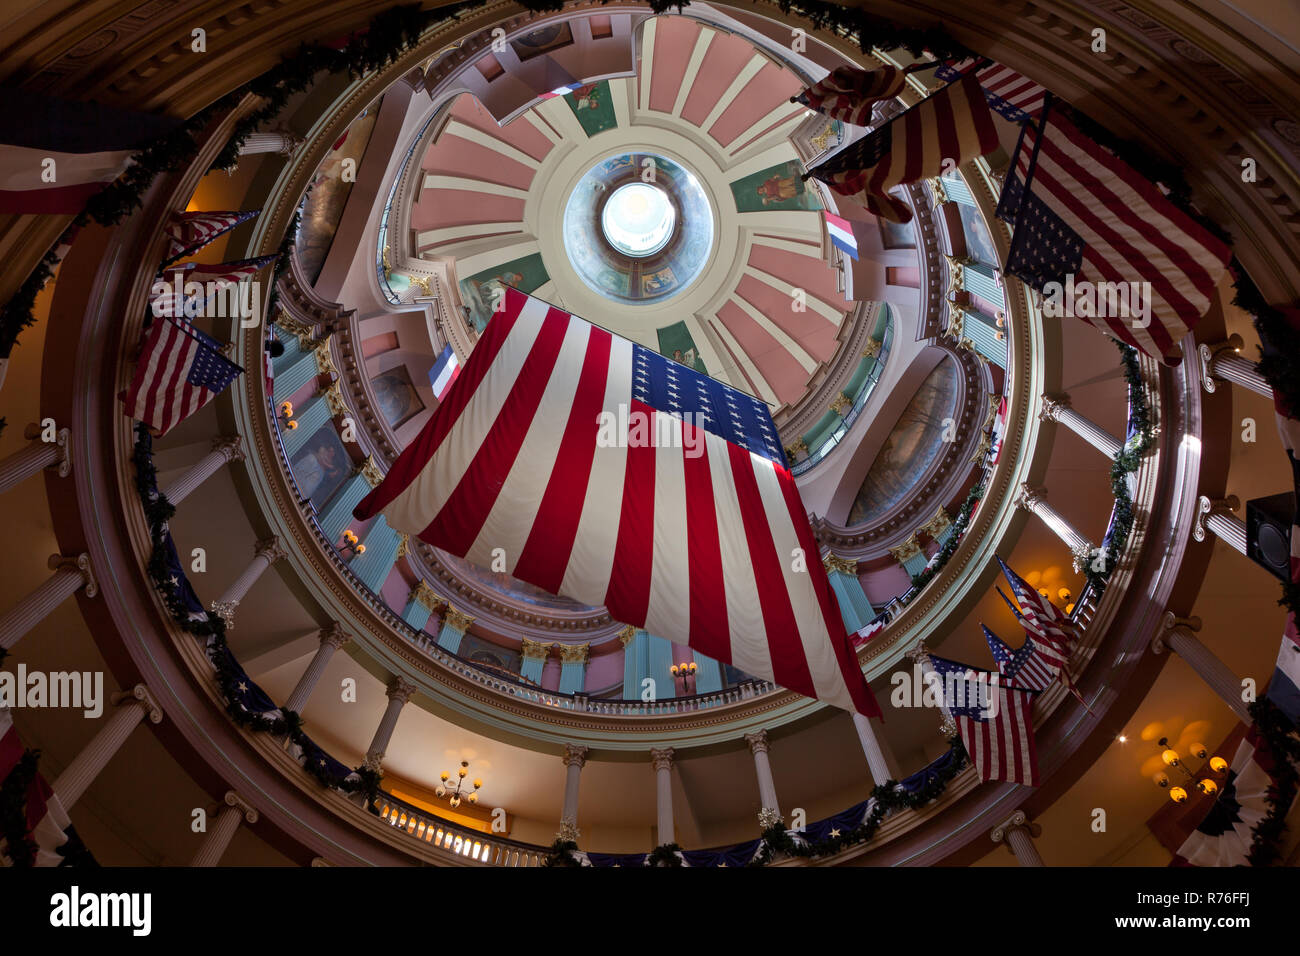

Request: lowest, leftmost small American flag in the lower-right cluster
left=928, top=654, right=1039, bottom=787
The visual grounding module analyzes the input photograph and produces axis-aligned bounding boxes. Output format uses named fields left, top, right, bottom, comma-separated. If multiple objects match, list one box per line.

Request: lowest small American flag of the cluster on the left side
left=120, top=317, right=243, bottom=434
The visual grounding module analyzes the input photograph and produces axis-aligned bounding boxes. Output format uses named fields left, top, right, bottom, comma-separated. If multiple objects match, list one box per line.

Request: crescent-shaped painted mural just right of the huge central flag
left=848, top=358, right=958, bottom=527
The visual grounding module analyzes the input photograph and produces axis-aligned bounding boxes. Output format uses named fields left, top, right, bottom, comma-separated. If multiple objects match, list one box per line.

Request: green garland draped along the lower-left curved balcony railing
left=131, top=423, right=380, bottom=813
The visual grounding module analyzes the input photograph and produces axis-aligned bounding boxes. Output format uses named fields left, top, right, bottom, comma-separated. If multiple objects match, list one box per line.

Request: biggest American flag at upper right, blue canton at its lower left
left=997, top=105, right=1231, bottom=359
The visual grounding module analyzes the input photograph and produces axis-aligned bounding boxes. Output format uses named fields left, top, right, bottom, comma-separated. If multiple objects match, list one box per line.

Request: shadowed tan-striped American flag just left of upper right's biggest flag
left=805, top=77, right=997, bottom=222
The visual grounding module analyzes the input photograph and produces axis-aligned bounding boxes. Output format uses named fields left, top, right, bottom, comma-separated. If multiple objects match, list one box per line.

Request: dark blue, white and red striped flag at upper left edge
left=0, top=88, right=181, bottom=215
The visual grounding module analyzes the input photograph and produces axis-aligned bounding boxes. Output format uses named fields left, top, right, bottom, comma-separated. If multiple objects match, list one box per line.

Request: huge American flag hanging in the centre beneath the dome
left=354, top=289, right=880, bottom=715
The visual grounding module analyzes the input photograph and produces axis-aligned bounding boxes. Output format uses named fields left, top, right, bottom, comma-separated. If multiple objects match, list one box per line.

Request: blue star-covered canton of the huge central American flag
left=632, top=342, right=785, bottom=467
